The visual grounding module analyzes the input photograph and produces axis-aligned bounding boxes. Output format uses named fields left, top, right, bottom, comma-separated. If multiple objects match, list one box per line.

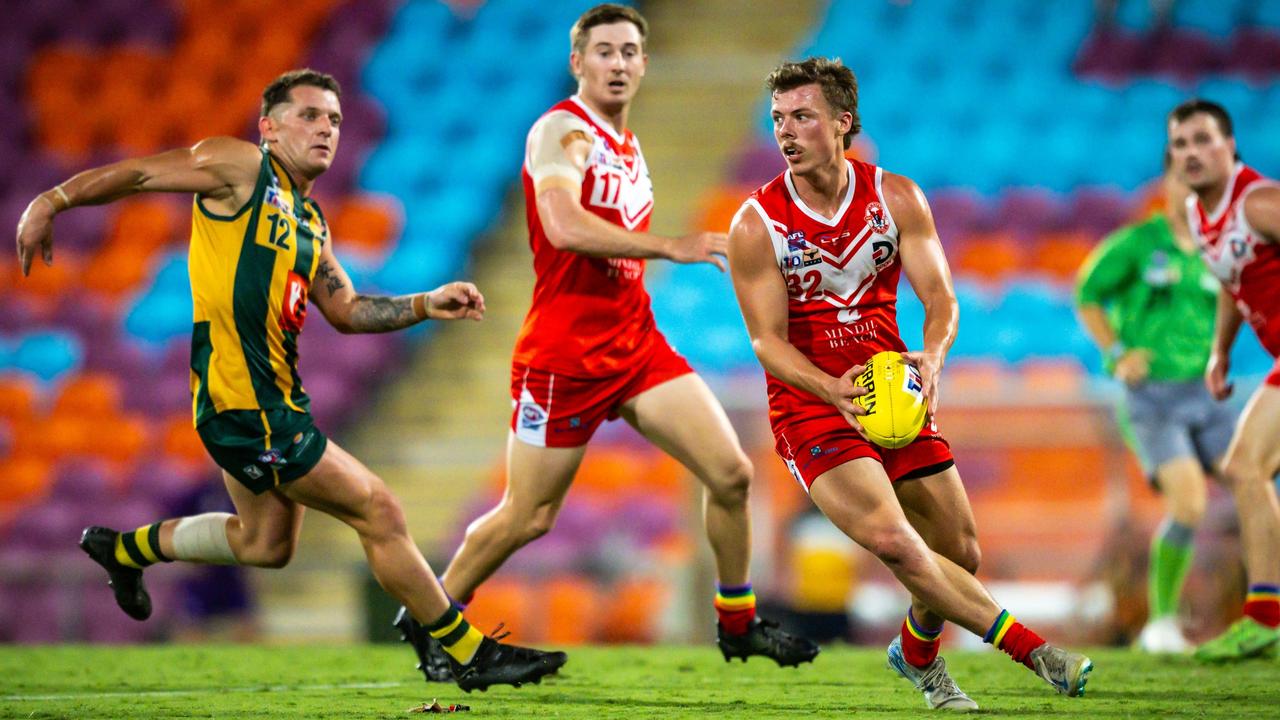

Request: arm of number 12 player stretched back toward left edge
left=18, top=137, right=262, bottom=275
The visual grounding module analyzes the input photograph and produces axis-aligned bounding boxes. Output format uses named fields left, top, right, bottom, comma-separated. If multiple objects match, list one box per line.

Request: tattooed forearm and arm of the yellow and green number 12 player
left=311, top=242, right=484, bottom=333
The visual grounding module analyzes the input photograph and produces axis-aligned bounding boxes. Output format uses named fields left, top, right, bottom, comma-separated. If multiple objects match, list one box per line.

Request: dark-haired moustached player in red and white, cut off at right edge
left=1169, top=100, right=1280, bottom=661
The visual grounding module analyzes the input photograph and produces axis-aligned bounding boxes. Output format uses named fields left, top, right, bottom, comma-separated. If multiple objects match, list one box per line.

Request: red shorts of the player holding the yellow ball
left=773, top=407, right=955, bottom=492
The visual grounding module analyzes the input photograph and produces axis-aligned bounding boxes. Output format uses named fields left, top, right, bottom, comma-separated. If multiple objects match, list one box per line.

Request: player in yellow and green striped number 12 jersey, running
left=8, top=69, right=564, bottom=691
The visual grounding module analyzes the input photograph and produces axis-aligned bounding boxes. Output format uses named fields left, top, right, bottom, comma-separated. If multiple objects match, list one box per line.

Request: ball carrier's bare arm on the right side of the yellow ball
left=882, top=173, right=960, bottom=414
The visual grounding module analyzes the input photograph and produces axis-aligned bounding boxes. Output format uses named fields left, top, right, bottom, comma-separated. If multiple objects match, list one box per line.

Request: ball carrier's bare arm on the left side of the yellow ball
left=728, top=199, right=867, bottom=432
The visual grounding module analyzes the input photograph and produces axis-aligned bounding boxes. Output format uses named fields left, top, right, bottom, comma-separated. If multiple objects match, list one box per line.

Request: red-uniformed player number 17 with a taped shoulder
left=397, top=4, right=818, bottom=680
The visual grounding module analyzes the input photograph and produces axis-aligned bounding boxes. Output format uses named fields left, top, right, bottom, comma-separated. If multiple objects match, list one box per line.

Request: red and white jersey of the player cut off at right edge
left=1187, top=163, right=1280, bottom=356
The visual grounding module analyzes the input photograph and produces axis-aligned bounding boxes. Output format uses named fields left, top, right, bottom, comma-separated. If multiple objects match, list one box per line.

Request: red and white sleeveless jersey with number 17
left=515, top=97, right=655, bottom=377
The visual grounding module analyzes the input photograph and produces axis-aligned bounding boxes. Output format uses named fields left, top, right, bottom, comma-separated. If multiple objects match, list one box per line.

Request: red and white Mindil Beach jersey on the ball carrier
left=746, top=160, right=906, bottom=424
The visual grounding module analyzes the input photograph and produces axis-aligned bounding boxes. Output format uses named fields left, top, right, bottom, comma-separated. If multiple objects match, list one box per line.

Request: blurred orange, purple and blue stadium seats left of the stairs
left=0, top=0, right=604, bottom=641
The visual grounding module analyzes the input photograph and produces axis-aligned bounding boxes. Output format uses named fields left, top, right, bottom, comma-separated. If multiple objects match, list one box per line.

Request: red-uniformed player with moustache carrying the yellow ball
left=728, top=58, right=1093, bottom=710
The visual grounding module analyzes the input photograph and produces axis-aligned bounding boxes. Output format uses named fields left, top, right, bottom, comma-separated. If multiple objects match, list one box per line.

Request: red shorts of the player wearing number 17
left=511, top=337, right=694, bottom=447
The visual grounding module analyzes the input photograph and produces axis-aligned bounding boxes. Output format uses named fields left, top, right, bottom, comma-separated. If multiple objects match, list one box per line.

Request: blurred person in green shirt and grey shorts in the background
left=1075, top=154, right=1235, bottom=652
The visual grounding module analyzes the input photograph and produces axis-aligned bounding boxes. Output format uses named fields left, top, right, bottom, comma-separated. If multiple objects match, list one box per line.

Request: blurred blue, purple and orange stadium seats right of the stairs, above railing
left=650, top=0, right=1280, bottom=374
